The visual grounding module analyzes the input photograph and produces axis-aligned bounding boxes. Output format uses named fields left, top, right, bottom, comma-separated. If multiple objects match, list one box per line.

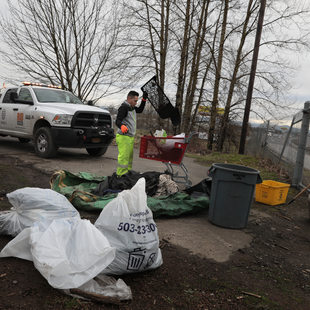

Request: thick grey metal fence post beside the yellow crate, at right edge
left=292, top=101, right=310, bottom=187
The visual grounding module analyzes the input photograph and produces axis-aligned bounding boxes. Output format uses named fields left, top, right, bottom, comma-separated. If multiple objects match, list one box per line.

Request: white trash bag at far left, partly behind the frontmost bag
left=0, top=187, right=80, bottom=236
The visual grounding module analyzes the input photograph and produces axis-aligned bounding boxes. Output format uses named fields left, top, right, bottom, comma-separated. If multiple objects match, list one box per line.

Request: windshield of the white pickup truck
left=33, top=88, right=83, bottom=104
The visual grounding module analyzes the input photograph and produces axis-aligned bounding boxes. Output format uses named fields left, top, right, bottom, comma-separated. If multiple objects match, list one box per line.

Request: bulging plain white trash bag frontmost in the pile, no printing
left=0, top=219, right=115, bottom=289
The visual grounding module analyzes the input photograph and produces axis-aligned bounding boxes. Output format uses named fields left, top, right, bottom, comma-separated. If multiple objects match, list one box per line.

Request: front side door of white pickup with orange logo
left=12, top=87, right=33, bottom=134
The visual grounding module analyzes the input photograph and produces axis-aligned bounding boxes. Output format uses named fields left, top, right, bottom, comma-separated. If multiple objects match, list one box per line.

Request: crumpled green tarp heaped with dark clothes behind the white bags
left=50, top=170, right=211, bottom=218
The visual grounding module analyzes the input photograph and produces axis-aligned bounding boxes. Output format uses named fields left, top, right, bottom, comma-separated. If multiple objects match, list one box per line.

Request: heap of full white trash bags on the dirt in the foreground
left=0, top=177, right=163, bottom=303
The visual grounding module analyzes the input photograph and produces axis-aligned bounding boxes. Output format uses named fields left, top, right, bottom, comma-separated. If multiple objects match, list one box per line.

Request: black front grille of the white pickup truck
left=72, top=112, right=111, bottom=128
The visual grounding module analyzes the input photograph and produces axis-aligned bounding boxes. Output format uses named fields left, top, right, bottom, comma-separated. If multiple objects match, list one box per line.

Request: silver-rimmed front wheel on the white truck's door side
left=34, top=127, right=57, bottom=158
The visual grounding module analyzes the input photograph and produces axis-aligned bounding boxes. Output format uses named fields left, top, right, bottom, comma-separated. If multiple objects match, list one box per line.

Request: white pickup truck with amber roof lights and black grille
left=0, top=82, right=114, bottom=158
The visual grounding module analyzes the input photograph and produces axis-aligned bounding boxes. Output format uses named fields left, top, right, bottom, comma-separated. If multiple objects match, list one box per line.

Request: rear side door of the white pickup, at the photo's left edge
left=0, top=88, right=17, bottom=133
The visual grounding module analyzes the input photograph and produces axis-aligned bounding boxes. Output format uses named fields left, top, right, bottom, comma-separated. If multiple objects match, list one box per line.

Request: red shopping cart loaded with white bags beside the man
left=139, top=133, right=195, bottom=187
